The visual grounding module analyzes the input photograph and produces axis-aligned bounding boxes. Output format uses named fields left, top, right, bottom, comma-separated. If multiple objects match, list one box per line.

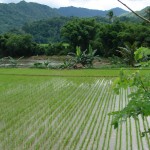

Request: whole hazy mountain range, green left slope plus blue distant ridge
left=0, top=1, right=127, bottom=33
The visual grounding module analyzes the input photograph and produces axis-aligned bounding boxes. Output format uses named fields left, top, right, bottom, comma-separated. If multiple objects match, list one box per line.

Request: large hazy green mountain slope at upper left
left=0, top=1, right=60, bottom=33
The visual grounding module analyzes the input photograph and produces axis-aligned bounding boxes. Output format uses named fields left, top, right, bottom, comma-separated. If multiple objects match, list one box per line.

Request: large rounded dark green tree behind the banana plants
left=61, top=18, right=98, bottom=50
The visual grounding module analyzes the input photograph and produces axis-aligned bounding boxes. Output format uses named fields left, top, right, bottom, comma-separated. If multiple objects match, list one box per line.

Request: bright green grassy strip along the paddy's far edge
left=0, top=68, right=150, bottom=77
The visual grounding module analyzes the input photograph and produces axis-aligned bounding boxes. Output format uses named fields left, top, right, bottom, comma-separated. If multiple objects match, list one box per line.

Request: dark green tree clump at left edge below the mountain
left=0, top=34, right=43, bottom=57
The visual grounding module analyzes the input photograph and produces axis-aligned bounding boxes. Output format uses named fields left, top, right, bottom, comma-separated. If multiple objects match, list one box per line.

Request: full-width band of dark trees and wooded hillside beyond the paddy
left=0, top=17, right=150, bottom=57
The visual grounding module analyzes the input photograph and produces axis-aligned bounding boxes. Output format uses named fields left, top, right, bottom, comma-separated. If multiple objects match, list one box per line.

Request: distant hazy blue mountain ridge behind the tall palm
left=58, top=6, right=128, bottom=17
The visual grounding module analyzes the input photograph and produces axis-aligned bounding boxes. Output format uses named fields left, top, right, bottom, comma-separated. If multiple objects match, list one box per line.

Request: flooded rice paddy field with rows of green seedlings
left=0, top=69, right=150, bottom=150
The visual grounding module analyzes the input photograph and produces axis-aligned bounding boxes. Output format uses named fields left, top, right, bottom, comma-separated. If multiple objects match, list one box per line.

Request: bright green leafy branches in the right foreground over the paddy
left=110, top=48, right=150, bottom=136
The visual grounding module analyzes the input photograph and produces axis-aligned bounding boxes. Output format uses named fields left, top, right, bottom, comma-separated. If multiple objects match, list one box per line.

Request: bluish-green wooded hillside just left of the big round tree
left=22, top=17, right=71, bottom=43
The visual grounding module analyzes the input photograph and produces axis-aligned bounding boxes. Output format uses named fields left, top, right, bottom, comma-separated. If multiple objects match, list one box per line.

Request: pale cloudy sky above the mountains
left=0, top=0, right=150, bottom=10
